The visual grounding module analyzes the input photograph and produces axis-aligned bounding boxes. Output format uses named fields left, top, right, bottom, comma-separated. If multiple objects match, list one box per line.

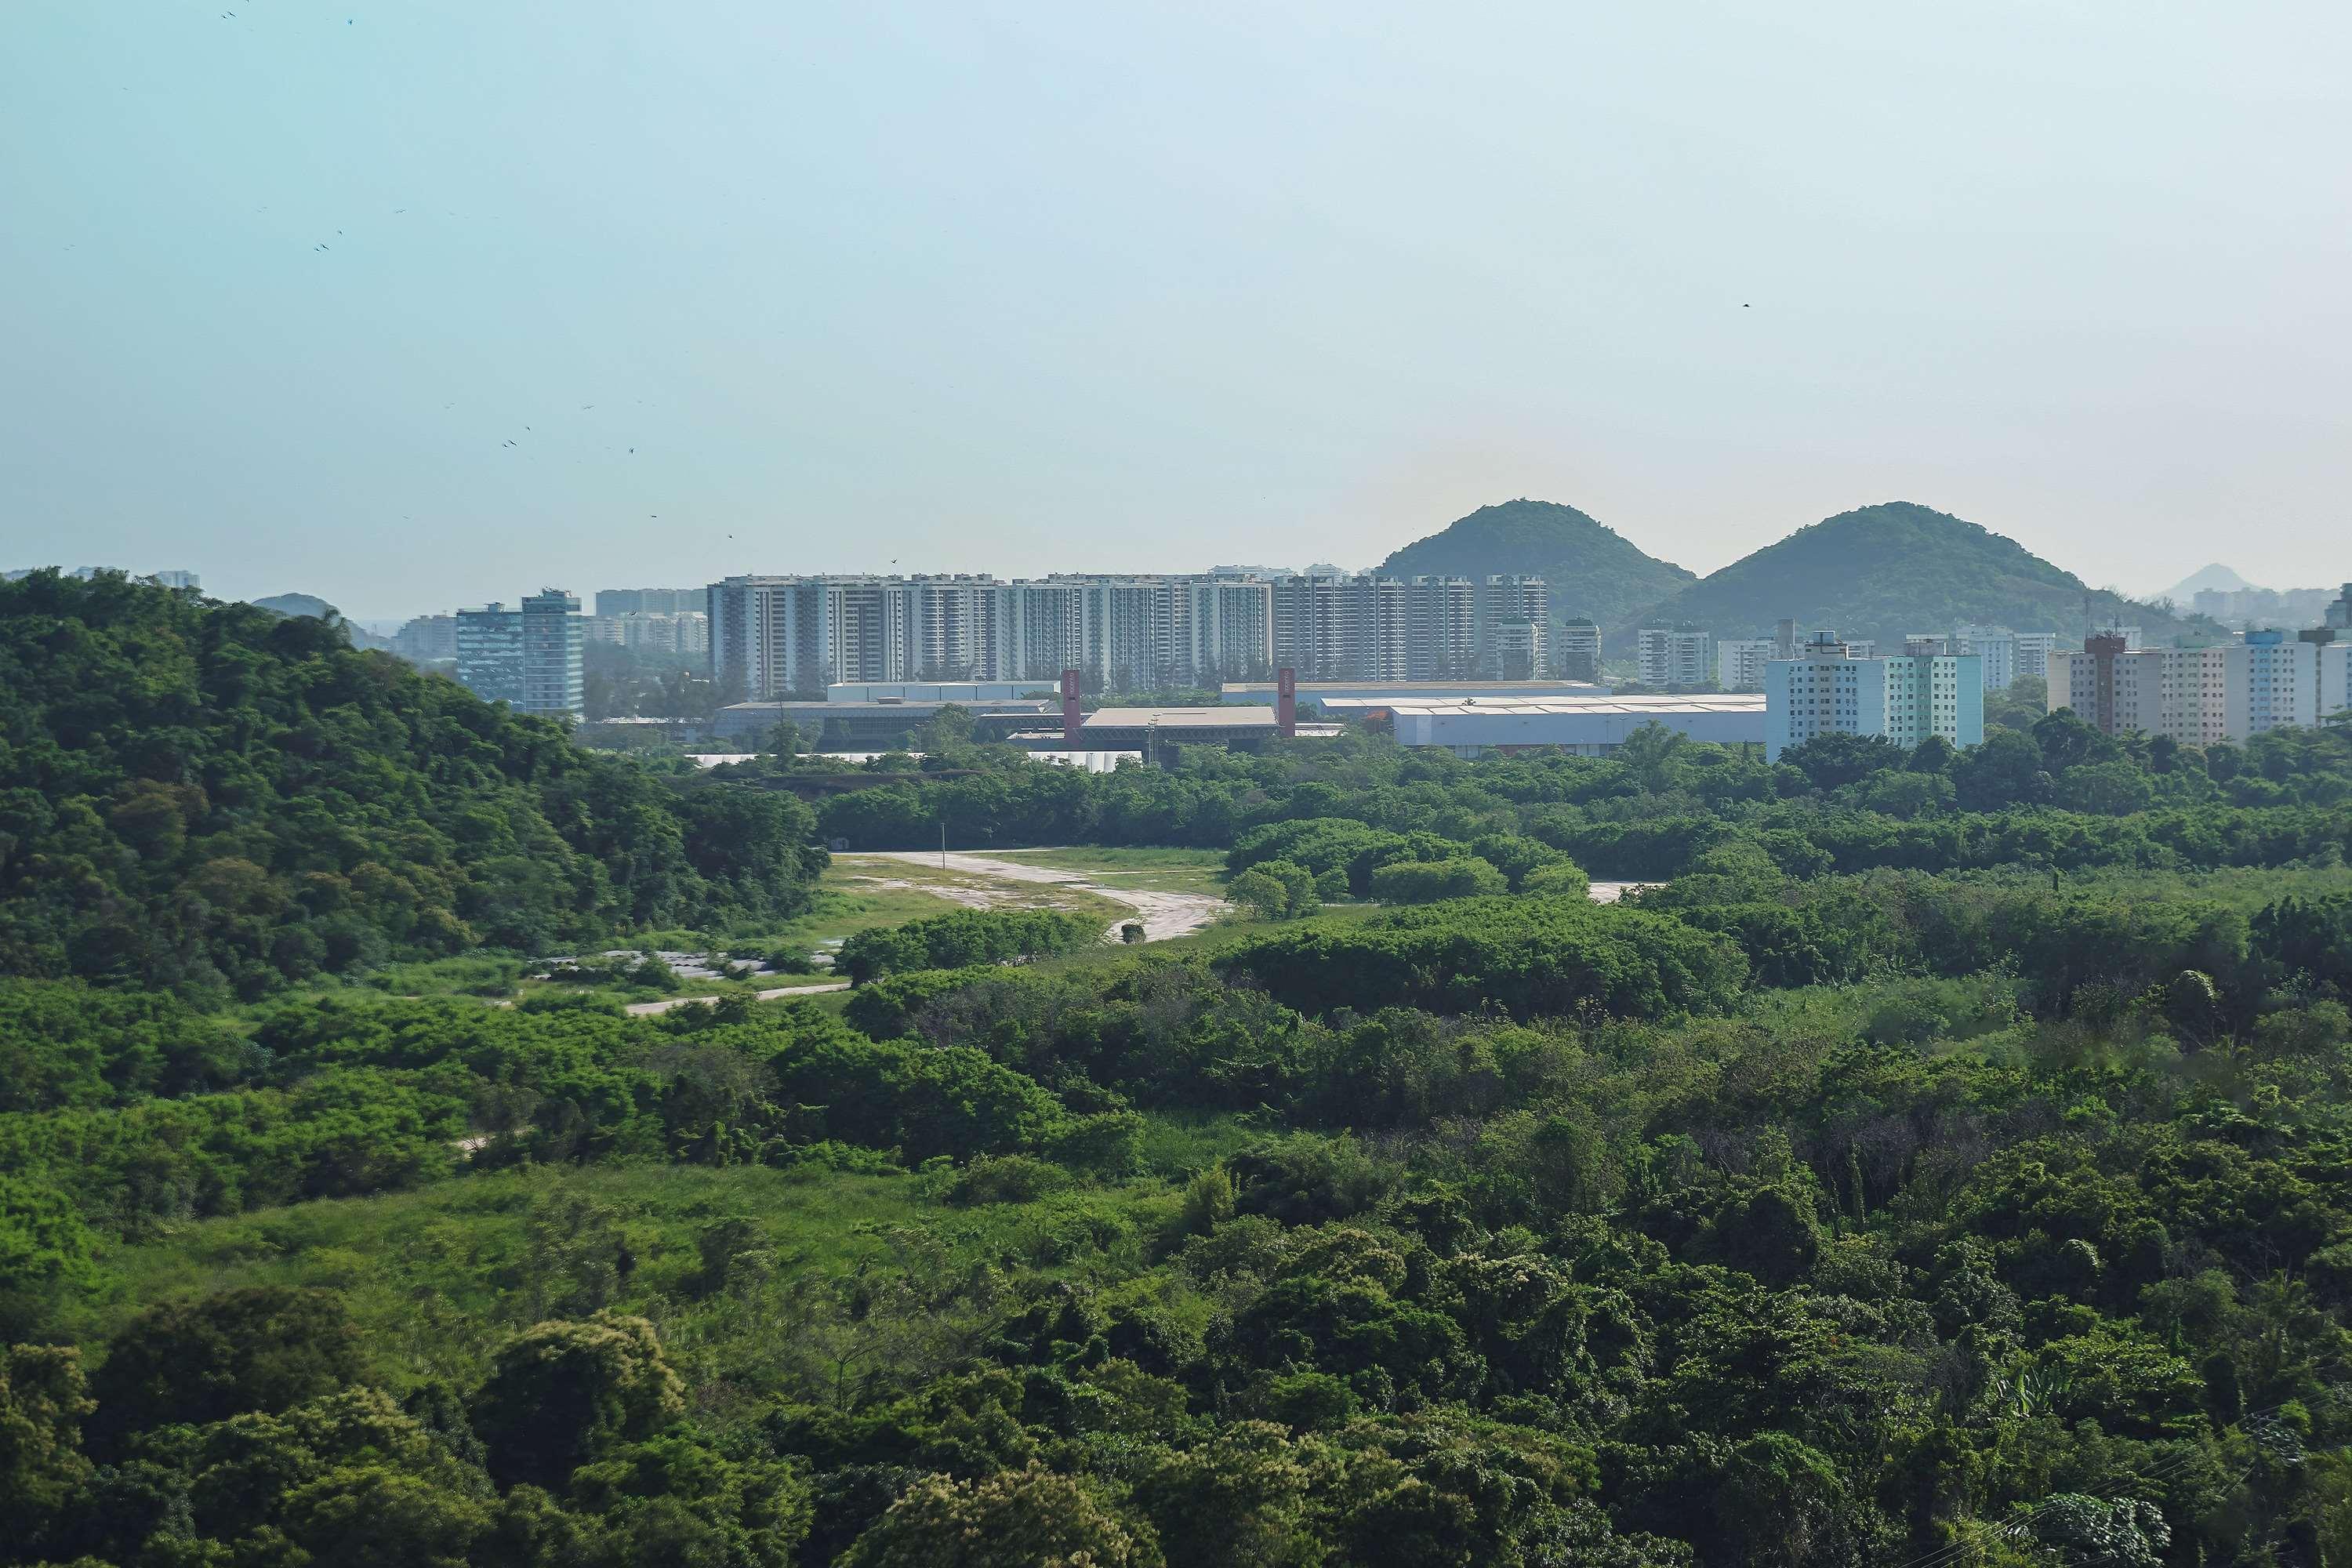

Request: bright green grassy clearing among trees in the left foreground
left=71, top=1116, right=1251, bottom=1389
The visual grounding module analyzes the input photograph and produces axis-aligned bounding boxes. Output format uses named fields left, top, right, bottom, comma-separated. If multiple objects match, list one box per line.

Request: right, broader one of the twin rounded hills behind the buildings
left=1611, top=501, right=2218, bottom=642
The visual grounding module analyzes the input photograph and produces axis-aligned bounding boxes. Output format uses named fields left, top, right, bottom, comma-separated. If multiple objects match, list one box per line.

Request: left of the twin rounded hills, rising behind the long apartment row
left=1381, top=501, right=1696, bottom=626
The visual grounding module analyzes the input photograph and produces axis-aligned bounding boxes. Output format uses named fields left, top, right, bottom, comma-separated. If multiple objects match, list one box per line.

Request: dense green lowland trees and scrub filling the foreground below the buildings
left=0, top=583, right=2352, bottom=1568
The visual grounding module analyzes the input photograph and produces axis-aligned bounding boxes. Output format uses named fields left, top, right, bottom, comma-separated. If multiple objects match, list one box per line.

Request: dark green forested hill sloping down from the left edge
left=0, top=574, right=818, bottom=996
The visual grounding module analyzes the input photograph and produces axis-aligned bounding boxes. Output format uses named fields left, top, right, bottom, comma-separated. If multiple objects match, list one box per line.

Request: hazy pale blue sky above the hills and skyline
left=0, top=0, right=2352, bottom=616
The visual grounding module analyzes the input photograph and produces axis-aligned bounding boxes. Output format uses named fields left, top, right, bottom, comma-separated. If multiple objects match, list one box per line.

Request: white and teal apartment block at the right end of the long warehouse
left=1764, top=633, right=1985, bottom=762
